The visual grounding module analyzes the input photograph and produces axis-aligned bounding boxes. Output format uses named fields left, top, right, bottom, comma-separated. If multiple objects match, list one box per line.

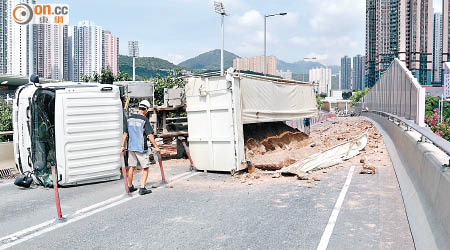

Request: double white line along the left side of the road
left=0, top=172, right=200, bottom=249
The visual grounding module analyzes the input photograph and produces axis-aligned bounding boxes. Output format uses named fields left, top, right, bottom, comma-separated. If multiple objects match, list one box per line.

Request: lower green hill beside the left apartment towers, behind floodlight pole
left=119, top=55, right=178, bottom=81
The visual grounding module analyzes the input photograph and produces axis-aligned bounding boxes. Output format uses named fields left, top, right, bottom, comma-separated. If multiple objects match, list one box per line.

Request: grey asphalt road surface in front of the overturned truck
left=0, top=155, right=414, bottom=249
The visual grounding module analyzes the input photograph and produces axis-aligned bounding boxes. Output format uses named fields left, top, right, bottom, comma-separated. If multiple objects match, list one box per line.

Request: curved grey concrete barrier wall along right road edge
left=363, top=113, right=450, bottom=249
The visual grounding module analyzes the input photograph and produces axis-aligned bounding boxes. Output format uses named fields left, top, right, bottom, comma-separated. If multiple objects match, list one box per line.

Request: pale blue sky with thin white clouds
left=38, top=0, right=439, bottom=65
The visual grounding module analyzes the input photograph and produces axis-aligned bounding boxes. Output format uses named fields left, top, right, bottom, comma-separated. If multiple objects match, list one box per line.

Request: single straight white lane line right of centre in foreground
left=317, top=166, right=355, bottom=250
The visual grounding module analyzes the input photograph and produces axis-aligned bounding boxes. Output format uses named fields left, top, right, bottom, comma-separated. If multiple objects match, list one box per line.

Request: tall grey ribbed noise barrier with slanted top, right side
left=363, top=58, right=425, bottom=127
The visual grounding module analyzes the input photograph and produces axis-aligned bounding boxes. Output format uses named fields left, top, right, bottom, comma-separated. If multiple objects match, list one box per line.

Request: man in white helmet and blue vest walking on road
left=121, top=100, right=161, bottom=195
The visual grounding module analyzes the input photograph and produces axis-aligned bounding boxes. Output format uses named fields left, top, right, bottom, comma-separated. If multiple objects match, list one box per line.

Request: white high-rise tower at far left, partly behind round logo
left=6, top=0, right=36, bottom=76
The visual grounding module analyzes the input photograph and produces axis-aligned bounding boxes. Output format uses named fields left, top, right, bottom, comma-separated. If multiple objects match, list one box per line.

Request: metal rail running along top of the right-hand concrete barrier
left=364, top=110, right=450, bottom=157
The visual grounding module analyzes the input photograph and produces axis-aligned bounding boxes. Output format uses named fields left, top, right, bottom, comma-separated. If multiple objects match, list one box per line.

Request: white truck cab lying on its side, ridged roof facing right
left=13, top=82, right=123, bottom=186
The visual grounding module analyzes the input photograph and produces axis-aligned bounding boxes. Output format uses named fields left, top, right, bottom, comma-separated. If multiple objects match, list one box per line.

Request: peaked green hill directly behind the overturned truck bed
left=178, top=49, right=239, bottom=70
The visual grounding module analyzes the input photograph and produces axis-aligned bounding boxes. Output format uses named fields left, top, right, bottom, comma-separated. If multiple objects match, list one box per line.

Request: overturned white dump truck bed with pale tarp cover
left=185, top=69, right=317, bottom=174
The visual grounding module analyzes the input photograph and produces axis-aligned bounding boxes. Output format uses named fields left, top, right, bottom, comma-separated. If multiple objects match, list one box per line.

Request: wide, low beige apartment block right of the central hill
left=233, top=56, right=278, bottom=75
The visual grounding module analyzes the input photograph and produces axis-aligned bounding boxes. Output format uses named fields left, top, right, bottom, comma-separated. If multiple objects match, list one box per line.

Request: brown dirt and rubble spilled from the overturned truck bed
left=235, top=117, right=392, bottom=188
